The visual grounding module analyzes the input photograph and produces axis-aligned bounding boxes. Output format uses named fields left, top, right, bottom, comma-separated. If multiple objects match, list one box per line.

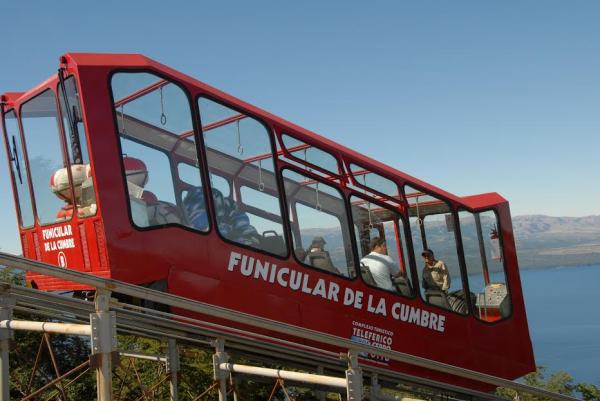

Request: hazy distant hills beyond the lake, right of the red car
left=513, top=215, right=600, bottom=268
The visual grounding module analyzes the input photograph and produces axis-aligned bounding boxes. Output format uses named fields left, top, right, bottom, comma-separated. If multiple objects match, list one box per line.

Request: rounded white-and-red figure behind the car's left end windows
left=50, top=164, right=96, bottom=221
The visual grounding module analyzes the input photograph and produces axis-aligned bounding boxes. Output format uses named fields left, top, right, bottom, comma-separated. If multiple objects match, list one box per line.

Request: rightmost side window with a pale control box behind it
left=458, top=210, right=511, bottom=322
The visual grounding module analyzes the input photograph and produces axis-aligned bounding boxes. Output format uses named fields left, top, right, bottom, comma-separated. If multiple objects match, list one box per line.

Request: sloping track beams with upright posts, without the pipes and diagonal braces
left=0, top=252, right=576, bottom=401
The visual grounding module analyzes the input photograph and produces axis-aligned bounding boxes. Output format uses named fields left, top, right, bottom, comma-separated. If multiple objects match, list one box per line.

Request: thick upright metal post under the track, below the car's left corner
left=90, top=290, right=119, bottom=401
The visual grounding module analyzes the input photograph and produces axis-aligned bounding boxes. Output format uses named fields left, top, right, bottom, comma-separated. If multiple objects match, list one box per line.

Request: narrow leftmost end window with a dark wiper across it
left=4, top=110, right=33, bottom=227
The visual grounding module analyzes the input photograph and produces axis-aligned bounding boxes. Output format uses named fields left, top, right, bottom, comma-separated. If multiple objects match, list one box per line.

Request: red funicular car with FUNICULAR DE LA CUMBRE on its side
left=2, top=54, right=534, bottom=388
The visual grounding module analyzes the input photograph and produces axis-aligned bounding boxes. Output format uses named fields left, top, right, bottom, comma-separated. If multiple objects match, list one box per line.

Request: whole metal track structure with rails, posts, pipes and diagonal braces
left=0, top=253, right=575, bottom=401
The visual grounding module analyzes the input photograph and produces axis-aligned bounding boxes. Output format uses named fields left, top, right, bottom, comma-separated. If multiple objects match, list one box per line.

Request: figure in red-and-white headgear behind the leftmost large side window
left=123, top=156, right=181, bottom=227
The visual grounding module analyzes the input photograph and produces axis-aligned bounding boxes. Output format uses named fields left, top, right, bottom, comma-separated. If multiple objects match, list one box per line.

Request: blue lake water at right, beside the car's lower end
left=521, top=265, right=600, bottom=385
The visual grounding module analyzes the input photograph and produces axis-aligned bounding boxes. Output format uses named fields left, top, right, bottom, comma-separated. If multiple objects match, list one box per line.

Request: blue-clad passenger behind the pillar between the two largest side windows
left=183, top=187, right=261, bottom=248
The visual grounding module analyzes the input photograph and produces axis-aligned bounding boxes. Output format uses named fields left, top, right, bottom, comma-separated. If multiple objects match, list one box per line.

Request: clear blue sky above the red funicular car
left=0, top=0, right=600, bottom=252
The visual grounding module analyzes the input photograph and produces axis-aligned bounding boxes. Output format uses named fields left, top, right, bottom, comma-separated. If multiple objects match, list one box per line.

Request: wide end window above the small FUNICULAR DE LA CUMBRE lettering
left=21, top=89, right=74, bottom=224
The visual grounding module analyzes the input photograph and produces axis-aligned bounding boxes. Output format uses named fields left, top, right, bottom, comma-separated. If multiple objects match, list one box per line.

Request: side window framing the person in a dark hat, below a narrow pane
left=283, top=170, right=356, bottom=277
